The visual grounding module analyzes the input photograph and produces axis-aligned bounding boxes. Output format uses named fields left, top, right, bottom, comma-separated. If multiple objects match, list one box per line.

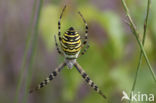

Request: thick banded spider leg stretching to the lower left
left=29, top=62, right=66, bottom=93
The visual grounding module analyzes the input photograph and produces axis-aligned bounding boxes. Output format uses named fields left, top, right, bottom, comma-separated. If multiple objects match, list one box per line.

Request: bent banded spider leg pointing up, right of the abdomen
left=78, top=11, right=88, bottom=47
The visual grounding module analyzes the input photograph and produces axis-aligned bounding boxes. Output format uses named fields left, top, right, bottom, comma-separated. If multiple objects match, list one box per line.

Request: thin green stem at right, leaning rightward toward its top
left=129, top=0, right=151, bottom=103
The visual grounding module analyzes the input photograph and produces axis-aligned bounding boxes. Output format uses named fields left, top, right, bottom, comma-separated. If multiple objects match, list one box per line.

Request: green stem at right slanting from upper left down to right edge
left=122, top=0, right=156, bottom=82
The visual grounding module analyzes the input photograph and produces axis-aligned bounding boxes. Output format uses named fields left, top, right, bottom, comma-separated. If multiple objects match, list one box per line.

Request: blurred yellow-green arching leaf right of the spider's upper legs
left=80, top=5, right=124, bottom=58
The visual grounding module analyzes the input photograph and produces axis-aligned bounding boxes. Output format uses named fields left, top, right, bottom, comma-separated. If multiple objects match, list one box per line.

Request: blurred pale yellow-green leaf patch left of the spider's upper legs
left=40, top=5, right=58, bottom=51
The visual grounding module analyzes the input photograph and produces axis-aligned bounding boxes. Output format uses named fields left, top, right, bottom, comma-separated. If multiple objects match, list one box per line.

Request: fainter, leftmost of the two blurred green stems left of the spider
left=14, top=0, right=37, bottom=103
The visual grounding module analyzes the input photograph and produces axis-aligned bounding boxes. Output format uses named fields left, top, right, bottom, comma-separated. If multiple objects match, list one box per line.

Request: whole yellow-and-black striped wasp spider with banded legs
left=30, top=5, right=106, bottom=99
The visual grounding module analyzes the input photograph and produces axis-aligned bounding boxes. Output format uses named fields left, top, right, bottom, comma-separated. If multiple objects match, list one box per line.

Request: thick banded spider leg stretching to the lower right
left=74, top=62, right=107, bottom=99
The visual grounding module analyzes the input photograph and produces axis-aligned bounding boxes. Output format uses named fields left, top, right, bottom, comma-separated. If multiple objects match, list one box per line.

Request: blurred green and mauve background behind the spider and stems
left=0, top=0, right=156, bottom=103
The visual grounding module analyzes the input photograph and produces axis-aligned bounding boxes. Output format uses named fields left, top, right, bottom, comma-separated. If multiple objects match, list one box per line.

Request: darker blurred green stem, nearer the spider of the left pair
left=23, top=0, right=43, bottom=103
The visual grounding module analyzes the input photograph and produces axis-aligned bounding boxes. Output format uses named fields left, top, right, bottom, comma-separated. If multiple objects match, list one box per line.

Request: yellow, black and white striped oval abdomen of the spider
left=61, top=27, right=81, bottom=55
